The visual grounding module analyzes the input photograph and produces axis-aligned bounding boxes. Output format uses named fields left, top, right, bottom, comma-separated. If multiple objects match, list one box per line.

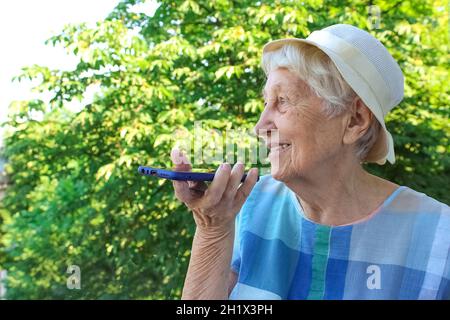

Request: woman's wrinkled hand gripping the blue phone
left=171, top=149, right=258, bottom=233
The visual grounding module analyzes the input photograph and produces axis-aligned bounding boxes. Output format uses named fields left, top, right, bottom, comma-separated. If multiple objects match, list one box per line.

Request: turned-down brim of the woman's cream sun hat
left=263, top=38, right=395, bottom=165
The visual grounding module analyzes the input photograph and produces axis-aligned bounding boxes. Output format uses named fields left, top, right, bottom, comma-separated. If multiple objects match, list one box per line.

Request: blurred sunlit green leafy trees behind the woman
left=0, top=0, right=450, bottom=299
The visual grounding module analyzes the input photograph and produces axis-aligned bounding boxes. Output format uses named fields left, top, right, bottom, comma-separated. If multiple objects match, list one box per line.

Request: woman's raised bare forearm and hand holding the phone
left=172, top=149, right=258, bottom=299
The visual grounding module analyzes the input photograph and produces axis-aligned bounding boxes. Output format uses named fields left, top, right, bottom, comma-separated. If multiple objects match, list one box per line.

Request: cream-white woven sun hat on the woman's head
left=263, top=24, right=404, bottom=164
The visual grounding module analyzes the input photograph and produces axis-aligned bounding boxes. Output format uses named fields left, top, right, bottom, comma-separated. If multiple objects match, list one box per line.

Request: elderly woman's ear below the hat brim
left=343, top=96, right=373, bottom=144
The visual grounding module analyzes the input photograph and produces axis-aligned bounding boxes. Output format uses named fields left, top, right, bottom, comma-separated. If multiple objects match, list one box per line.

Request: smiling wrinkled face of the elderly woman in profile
left=255, top=68, right=345, bottom=182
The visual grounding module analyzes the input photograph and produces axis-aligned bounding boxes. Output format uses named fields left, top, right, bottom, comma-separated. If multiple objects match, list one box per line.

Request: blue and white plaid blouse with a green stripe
left=230, top=175, right=450, bottom=299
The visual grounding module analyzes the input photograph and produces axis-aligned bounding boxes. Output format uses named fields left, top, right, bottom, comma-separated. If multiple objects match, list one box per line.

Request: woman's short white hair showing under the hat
left=262, top=43, right=381, bottom=161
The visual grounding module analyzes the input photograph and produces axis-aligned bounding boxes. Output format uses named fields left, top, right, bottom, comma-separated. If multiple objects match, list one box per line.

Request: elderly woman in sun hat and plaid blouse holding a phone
left=172, top=25, right=450, bottom=299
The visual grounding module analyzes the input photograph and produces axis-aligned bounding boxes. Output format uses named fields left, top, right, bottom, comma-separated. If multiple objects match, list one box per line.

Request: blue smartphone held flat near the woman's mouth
left=138, top=166, right=259, bottom=182
